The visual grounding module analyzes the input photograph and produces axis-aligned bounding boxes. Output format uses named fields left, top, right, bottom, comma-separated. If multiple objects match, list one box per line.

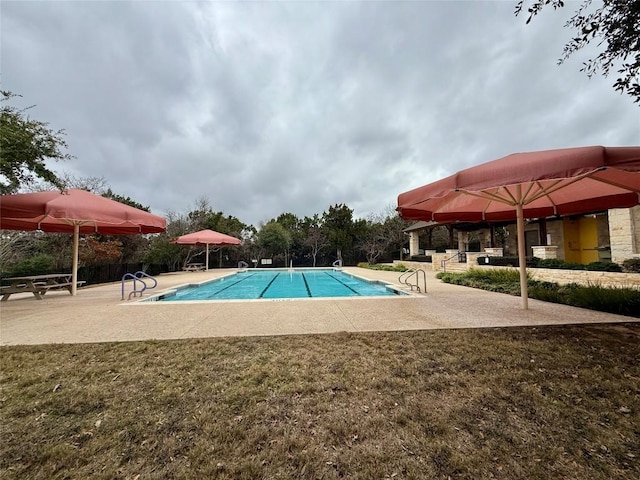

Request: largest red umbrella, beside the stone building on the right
left=397, top=146, right=640, bottom=309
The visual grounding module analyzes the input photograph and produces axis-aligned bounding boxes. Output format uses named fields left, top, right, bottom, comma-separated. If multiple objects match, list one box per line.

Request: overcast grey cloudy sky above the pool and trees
left=0, top=0, right=640, bottom=226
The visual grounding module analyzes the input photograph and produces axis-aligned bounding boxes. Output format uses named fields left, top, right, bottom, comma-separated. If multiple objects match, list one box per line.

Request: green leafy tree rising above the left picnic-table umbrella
left=0, top=91, right=73, bottom=194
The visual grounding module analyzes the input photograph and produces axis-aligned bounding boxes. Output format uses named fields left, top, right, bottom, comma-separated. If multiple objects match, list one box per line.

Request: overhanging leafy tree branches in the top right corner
left=515, top=0, right=640, bottom=103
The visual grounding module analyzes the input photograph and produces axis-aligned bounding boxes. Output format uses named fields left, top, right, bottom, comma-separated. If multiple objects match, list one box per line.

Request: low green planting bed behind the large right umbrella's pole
left=436, top=268, right=640, bottom=318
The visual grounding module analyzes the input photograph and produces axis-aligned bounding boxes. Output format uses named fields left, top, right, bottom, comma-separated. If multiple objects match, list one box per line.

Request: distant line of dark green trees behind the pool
left=0, top=177, right=416, bottom=275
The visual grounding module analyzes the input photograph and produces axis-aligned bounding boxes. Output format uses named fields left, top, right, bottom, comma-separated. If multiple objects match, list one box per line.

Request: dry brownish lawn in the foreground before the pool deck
left=0, top=323, right=640, bottom=480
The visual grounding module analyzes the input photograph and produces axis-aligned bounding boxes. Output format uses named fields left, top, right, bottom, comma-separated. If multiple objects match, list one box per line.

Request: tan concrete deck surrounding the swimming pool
left=0, top=267, right=639, bottom=345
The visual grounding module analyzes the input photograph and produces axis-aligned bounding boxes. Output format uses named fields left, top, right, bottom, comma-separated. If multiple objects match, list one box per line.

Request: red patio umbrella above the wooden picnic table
left=0, top=189, right=166, bottom=295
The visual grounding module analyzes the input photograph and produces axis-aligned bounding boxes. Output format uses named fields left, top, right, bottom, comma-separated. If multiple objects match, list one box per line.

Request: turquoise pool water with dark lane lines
left=157, top=269, right=402, bottom=302
